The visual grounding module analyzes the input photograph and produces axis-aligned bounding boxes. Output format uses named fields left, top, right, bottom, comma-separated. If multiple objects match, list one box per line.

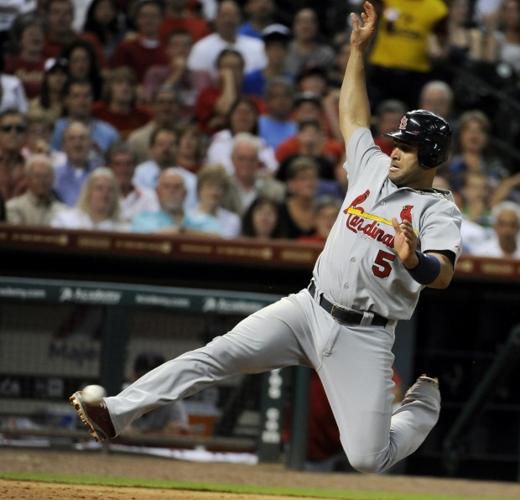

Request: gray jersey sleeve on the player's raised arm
left=344, top=128, right=390, bottom=184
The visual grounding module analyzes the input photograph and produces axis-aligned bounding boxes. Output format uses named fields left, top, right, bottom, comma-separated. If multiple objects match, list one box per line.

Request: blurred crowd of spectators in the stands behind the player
left=0, top=0, right=520, bottom=258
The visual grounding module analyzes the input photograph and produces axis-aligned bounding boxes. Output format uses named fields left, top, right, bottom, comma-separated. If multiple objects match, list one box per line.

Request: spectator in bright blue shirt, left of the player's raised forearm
left=258, top=78, right=298, bottom=149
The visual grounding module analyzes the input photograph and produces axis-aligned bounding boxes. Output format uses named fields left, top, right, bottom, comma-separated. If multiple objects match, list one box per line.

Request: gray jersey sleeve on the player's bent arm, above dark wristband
left=419, top=202, right=462, bottom=261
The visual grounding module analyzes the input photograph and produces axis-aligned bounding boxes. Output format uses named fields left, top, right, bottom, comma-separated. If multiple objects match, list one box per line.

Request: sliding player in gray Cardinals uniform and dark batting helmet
left=70, top=2, right=461, bottom=472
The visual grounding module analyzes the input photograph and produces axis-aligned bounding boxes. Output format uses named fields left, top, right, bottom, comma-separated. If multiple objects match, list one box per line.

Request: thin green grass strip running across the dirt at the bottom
left=0, top=472, right=490, bottom=500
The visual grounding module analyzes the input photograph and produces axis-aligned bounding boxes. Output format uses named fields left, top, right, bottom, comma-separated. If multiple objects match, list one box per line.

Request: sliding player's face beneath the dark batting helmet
left=388, top=141, right=431, bottom=188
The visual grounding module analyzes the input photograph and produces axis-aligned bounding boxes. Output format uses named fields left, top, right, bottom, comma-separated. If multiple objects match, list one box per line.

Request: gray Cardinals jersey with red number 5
left=313, top=128, right=462, bottom=319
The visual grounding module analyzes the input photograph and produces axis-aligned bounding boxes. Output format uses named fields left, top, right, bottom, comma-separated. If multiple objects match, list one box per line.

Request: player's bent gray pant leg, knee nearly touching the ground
left=318, top=325, right=440, bottom=472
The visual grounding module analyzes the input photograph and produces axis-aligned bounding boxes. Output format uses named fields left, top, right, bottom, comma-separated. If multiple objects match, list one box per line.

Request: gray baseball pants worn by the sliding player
left=105, top=289, right=440, bottom=472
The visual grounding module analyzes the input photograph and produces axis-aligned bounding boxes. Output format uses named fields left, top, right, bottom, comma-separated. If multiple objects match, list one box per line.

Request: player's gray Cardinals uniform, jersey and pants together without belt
left=105, top=129, right=460, bottom=472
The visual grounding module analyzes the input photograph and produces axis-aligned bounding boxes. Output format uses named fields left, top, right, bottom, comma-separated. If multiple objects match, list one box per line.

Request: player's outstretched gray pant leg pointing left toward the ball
left=100, top=292, right=316, bottom=434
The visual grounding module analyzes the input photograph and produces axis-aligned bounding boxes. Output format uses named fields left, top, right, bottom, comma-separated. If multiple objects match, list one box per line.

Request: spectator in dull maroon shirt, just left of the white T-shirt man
left=144, top=30, right=212, bottom=118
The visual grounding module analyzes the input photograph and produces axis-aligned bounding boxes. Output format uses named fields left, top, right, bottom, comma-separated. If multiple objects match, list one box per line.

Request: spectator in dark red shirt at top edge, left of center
left=111, top=0, right=168, bottom=82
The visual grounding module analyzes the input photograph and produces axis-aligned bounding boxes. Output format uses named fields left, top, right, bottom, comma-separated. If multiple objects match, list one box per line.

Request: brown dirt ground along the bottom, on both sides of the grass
left=0, top=449, right=520, bottom=500
